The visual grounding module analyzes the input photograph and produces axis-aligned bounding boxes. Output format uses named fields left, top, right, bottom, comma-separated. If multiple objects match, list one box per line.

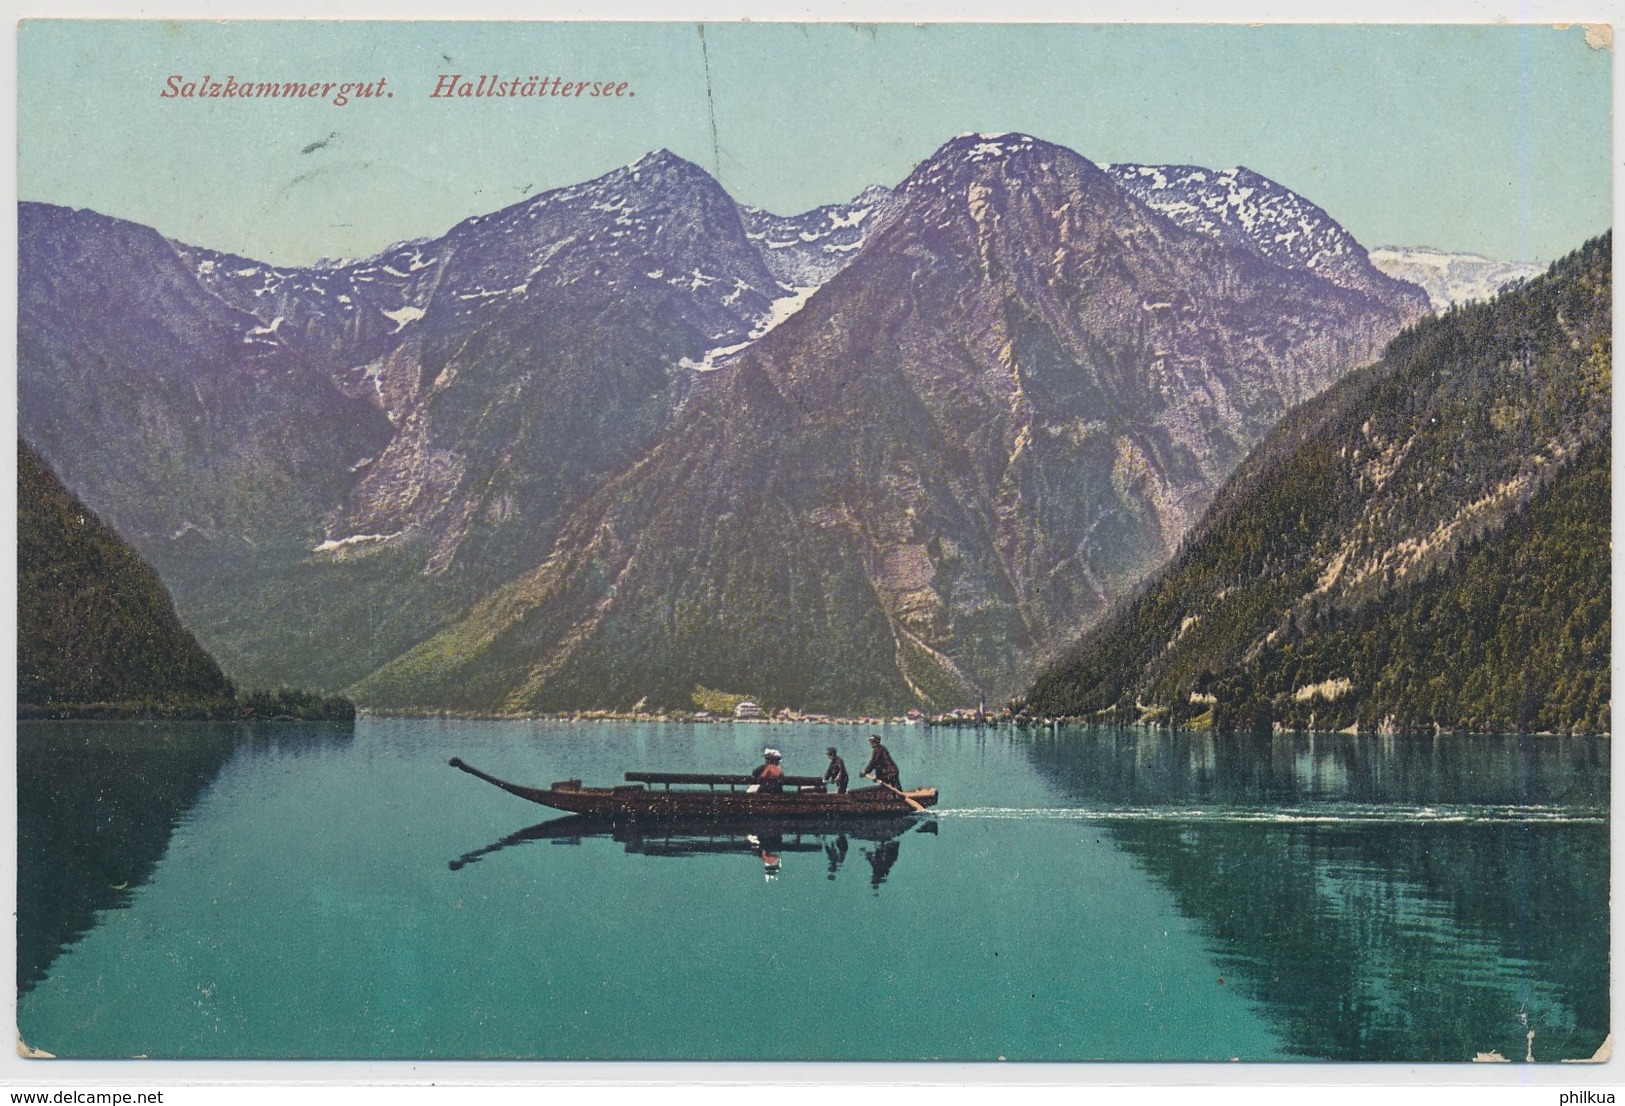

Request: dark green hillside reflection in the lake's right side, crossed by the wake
left=1029, top=731, right=1609, bottom=1061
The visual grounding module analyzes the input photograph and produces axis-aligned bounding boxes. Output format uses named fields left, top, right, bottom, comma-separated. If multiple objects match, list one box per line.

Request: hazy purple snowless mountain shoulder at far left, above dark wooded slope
left=18, top=205, right=390, bottom=570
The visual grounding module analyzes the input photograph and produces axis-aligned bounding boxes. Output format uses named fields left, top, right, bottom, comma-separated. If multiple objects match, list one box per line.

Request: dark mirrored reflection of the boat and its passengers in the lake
left=449, top=814, right=936, bottom=890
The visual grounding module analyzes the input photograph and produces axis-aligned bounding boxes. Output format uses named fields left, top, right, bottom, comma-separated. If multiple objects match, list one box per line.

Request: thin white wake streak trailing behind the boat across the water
left=931, top=804, right=1609, bottom=825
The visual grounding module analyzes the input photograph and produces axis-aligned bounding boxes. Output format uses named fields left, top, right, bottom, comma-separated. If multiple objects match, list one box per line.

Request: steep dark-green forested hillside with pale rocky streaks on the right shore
left=1027, top=234, right=1612, bottom=732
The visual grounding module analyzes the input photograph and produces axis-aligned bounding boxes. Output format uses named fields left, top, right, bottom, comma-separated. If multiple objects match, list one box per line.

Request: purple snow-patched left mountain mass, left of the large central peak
left=20, top=151, right=832, bottom=690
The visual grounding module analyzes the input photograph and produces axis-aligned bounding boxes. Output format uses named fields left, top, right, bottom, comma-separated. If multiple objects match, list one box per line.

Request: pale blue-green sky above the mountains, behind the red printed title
left=18, top=21, right=1612, bottom=263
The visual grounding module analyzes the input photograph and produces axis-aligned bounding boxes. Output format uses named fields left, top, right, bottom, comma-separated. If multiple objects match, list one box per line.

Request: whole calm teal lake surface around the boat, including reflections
left=18, top=719, right=1609, bottom=1061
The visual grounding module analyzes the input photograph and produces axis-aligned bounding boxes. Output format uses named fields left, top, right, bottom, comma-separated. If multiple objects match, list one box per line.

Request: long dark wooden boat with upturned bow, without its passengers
left=450, top=757, right=936, bottom=819
